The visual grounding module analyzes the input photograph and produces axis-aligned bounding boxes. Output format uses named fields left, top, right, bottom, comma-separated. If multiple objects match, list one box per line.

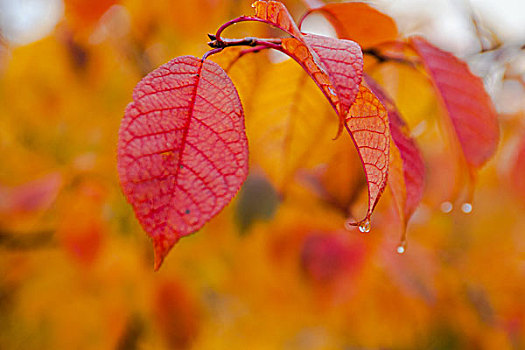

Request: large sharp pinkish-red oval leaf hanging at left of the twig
left=118, top=56, right=248, bottom=269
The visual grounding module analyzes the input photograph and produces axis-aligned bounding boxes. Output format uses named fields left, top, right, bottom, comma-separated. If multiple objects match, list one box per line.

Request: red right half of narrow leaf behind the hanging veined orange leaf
left=366, top=77, right=425, bottom=223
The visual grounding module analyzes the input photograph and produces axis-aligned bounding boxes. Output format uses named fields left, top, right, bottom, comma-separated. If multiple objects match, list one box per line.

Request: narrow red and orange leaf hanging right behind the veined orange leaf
left=366, top=77, right=425, bottom=224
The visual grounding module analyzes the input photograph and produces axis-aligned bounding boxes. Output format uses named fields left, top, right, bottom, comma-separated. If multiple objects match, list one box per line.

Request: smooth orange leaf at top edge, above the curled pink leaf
left=315, top=2, right=398, bottom=48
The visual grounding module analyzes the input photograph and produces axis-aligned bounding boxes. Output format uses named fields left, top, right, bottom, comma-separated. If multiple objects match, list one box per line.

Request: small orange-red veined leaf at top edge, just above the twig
left=252, top=1, right=302, bottom=38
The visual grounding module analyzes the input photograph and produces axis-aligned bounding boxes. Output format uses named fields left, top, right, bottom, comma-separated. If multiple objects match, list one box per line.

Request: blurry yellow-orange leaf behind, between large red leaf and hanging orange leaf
left=246, top=60, right=337, bottom=194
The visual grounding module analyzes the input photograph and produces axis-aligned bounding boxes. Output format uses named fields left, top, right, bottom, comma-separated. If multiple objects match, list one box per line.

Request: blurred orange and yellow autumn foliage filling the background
left=0, top=0, right=525, bottom=349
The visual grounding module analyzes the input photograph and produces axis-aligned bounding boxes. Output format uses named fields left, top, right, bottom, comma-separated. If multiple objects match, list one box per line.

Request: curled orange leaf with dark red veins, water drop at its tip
left=345, top=85, right=390, bottom=227
